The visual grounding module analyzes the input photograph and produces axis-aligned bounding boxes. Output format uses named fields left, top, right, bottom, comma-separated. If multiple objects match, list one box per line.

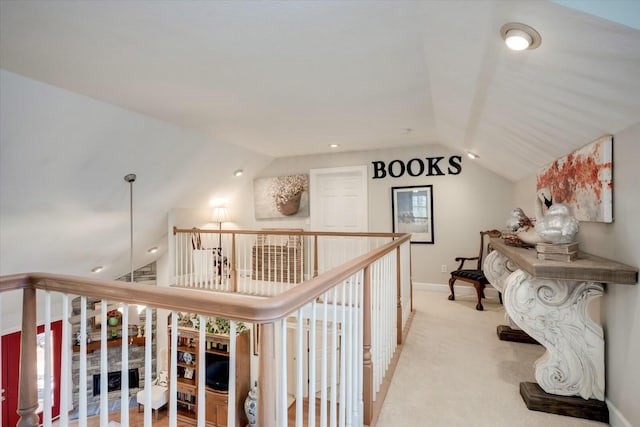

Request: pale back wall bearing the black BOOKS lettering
left=221, top=145, right=513, bottom=283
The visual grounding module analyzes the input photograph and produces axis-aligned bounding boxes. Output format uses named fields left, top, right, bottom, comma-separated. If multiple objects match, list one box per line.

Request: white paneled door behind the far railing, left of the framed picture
left=309, top=166, right=368, bottom=273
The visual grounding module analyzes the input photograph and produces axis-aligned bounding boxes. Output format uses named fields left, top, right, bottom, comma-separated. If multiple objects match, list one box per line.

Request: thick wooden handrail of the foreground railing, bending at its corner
left=0, top=232, right=410, bottom=323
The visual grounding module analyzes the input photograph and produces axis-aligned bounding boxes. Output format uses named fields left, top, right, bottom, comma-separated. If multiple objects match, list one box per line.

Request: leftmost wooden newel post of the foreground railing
left=17, top=288, right=38, bottom=427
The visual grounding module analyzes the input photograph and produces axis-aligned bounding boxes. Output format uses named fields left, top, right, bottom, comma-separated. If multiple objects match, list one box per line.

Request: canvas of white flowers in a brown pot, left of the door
left=253, top=175, right=309, bottom=219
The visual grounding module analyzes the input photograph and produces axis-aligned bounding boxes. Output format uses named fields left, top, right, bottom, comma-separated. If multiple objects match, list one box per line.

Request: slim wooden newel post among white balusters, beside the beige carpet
left=362, top=265, right=373, bottom=425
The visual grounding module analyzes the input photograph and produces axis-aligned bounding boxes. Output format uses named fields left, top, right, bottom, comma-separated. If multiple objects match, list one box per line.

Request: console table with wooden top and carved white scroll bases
left=484, top=238, right=638, bottom=422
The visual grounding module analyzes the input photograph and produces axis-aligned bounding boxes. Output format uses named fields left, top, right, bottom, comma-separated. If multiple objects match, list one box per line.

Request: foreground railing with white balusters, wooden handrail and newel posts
left=0, top=233, right=410, bottom=427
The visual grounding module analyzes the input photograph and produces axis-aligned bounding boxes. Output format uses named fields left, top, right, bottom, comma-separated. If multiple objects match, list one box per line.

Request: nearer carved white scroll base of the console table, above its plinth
left=504, top=270, right=604, bottom=400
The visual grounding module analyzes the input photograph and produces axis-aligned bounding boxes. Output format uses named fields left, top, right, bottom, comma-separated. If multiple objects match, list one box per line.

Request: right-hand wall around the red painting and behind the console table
left=513, top=123, right=640, bottom=427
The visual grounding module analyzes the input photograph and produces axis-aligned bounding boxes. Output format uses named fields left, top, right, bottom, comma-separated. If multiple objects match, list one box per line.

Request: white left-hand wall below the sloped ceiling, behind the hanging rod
left=0, top=70, right=272, bottom=279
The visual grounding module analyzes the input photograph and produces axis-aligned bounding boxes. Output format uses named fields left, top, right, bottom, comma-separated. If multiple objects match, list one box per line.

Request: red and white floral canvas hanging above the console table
left=536, top=135, right=613, bottom=222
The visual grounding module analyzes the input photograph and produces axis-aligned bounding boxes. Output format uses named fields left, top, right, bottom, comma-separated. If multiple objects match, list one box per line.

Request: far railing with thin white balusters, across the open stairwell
left=173, top=228, right=393, bottom=296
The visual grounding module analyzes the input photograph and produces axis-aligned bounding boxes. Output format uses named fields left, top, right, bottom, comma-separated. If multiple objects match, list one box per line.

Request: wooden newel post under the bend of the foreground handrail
left=257, top=323, right=276, bottom=427
